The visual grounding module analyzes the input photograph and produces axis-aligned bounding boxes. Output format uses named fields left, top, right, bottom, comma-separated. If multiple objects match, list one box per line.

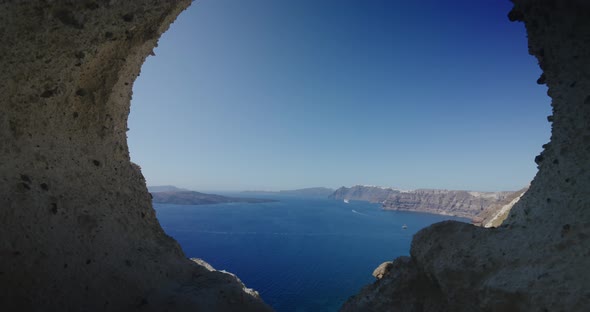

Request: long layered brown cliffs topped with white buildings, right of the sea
left=329, top=185, right=528, bottom=227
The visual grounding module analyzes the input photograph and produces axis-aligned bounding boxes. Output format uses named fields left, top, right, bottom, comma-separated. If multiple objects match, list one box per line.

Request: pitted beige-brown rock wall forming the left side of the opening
left=0, top=0, right=270, bottom=311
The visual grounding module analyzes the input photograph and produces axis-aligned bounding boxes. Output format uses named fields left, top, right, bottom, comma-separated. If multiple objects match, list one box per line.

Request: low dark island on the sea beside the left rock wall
left=148, top=185, right=277, bottom=205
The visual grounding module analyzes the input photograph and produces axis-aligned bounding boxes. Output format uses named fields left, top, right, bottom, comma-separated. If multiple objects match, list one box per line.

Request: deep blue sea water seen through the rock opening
left=154, top=194, right=465, bottom=312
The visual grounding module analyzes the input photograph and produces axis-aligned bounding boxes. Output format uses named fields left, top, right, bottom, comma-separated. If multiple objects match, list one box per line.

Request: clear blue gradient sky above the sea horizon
left=128, top=0, right=551, bottom=191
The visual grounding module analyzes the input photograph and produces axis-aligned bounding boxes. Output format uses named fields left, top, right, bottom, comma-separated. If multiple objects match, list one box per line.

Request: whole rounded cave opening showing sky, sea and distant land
left=129, top=1, right=551, bottom=311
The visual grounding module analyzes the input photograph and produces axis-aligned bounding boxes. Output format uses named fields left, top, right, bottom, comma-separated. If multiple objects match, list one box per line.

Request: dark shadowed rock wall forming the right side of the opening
left=342, top=0, right=590, bottom=311
